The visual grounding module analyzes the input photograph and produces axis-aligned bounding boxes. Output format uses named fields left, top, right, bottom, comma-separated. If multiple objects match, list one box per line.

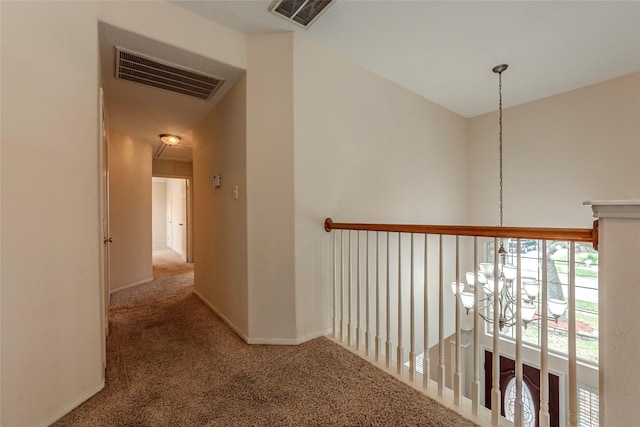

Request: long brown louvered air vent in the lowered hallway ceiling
left=116, top=46, right=224, bottom=100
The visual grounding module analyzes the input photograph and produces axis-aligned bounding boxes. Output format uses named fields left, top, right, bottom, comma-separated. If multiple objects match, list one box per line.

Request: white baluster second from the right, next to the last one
left=539, top=240, right=550, bottom=427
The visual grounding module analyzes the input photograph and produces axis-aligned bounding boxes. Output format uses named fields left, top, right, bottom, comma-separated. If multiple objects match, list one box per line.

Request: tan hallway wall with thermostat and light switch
left=193, top=77, right=249, bottom=339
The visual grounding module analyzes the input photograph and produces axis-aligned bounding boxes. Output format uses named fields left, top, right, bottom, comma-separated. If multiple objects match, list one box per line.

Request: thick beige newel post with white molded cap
left=585, top=200, right=640, bottom=426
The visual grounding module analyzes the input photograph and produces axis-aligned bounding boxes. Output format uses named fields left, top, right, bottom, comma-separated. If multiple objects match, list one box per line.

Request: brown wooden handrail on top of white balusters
left=324, top=218, right=598, bottom=249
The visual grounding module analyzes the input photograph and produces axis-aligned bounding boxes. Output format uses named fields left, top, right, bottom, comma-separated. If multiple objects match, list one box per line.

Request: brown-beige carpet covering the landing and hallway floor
left=54, top=249, right=474, bottom=426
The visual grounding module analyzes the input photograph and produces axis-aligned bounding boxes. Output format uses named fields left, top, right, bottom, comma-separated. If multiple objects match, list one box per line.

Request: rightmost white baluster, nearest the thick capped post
left=569, top=242, right=578, bottom=427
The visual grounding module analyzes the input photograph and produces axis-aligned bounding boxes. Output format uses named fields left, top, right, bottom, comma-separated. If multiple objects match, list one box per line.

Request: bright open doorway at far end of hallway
left=151, top=177, right=193, bottom=262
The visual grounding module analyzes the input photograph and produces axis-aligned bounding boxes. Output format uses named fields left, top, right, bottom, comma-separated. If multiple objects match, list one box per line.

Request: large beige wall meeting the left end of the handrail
left=292, top=37, right=468, bottom=344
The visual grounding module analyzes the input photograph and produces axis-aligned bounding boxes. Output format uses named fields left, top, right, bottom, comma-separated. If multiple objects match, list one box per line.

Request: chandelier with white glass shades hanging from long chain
left=451, top=64, right=567, bottom=331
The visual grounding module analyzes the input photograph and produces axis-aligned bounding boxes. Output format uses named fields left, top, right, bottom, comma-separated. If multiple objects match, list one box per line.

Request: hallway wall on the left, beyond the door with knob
left=109, top=132, right=153, bottom=292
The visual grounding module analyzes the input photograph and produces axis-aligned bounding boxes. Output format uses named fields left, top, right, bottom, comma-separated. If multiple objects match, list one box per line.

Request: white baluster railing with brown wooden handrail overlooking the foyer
left=325, top=219, right=594, bottom=426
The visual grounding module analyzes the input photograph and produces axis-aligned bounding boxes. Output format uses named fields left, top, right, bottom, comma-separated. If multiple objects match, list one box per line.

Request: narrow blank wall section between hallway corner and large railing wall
left=246, top=34, right=297, bottom=343
